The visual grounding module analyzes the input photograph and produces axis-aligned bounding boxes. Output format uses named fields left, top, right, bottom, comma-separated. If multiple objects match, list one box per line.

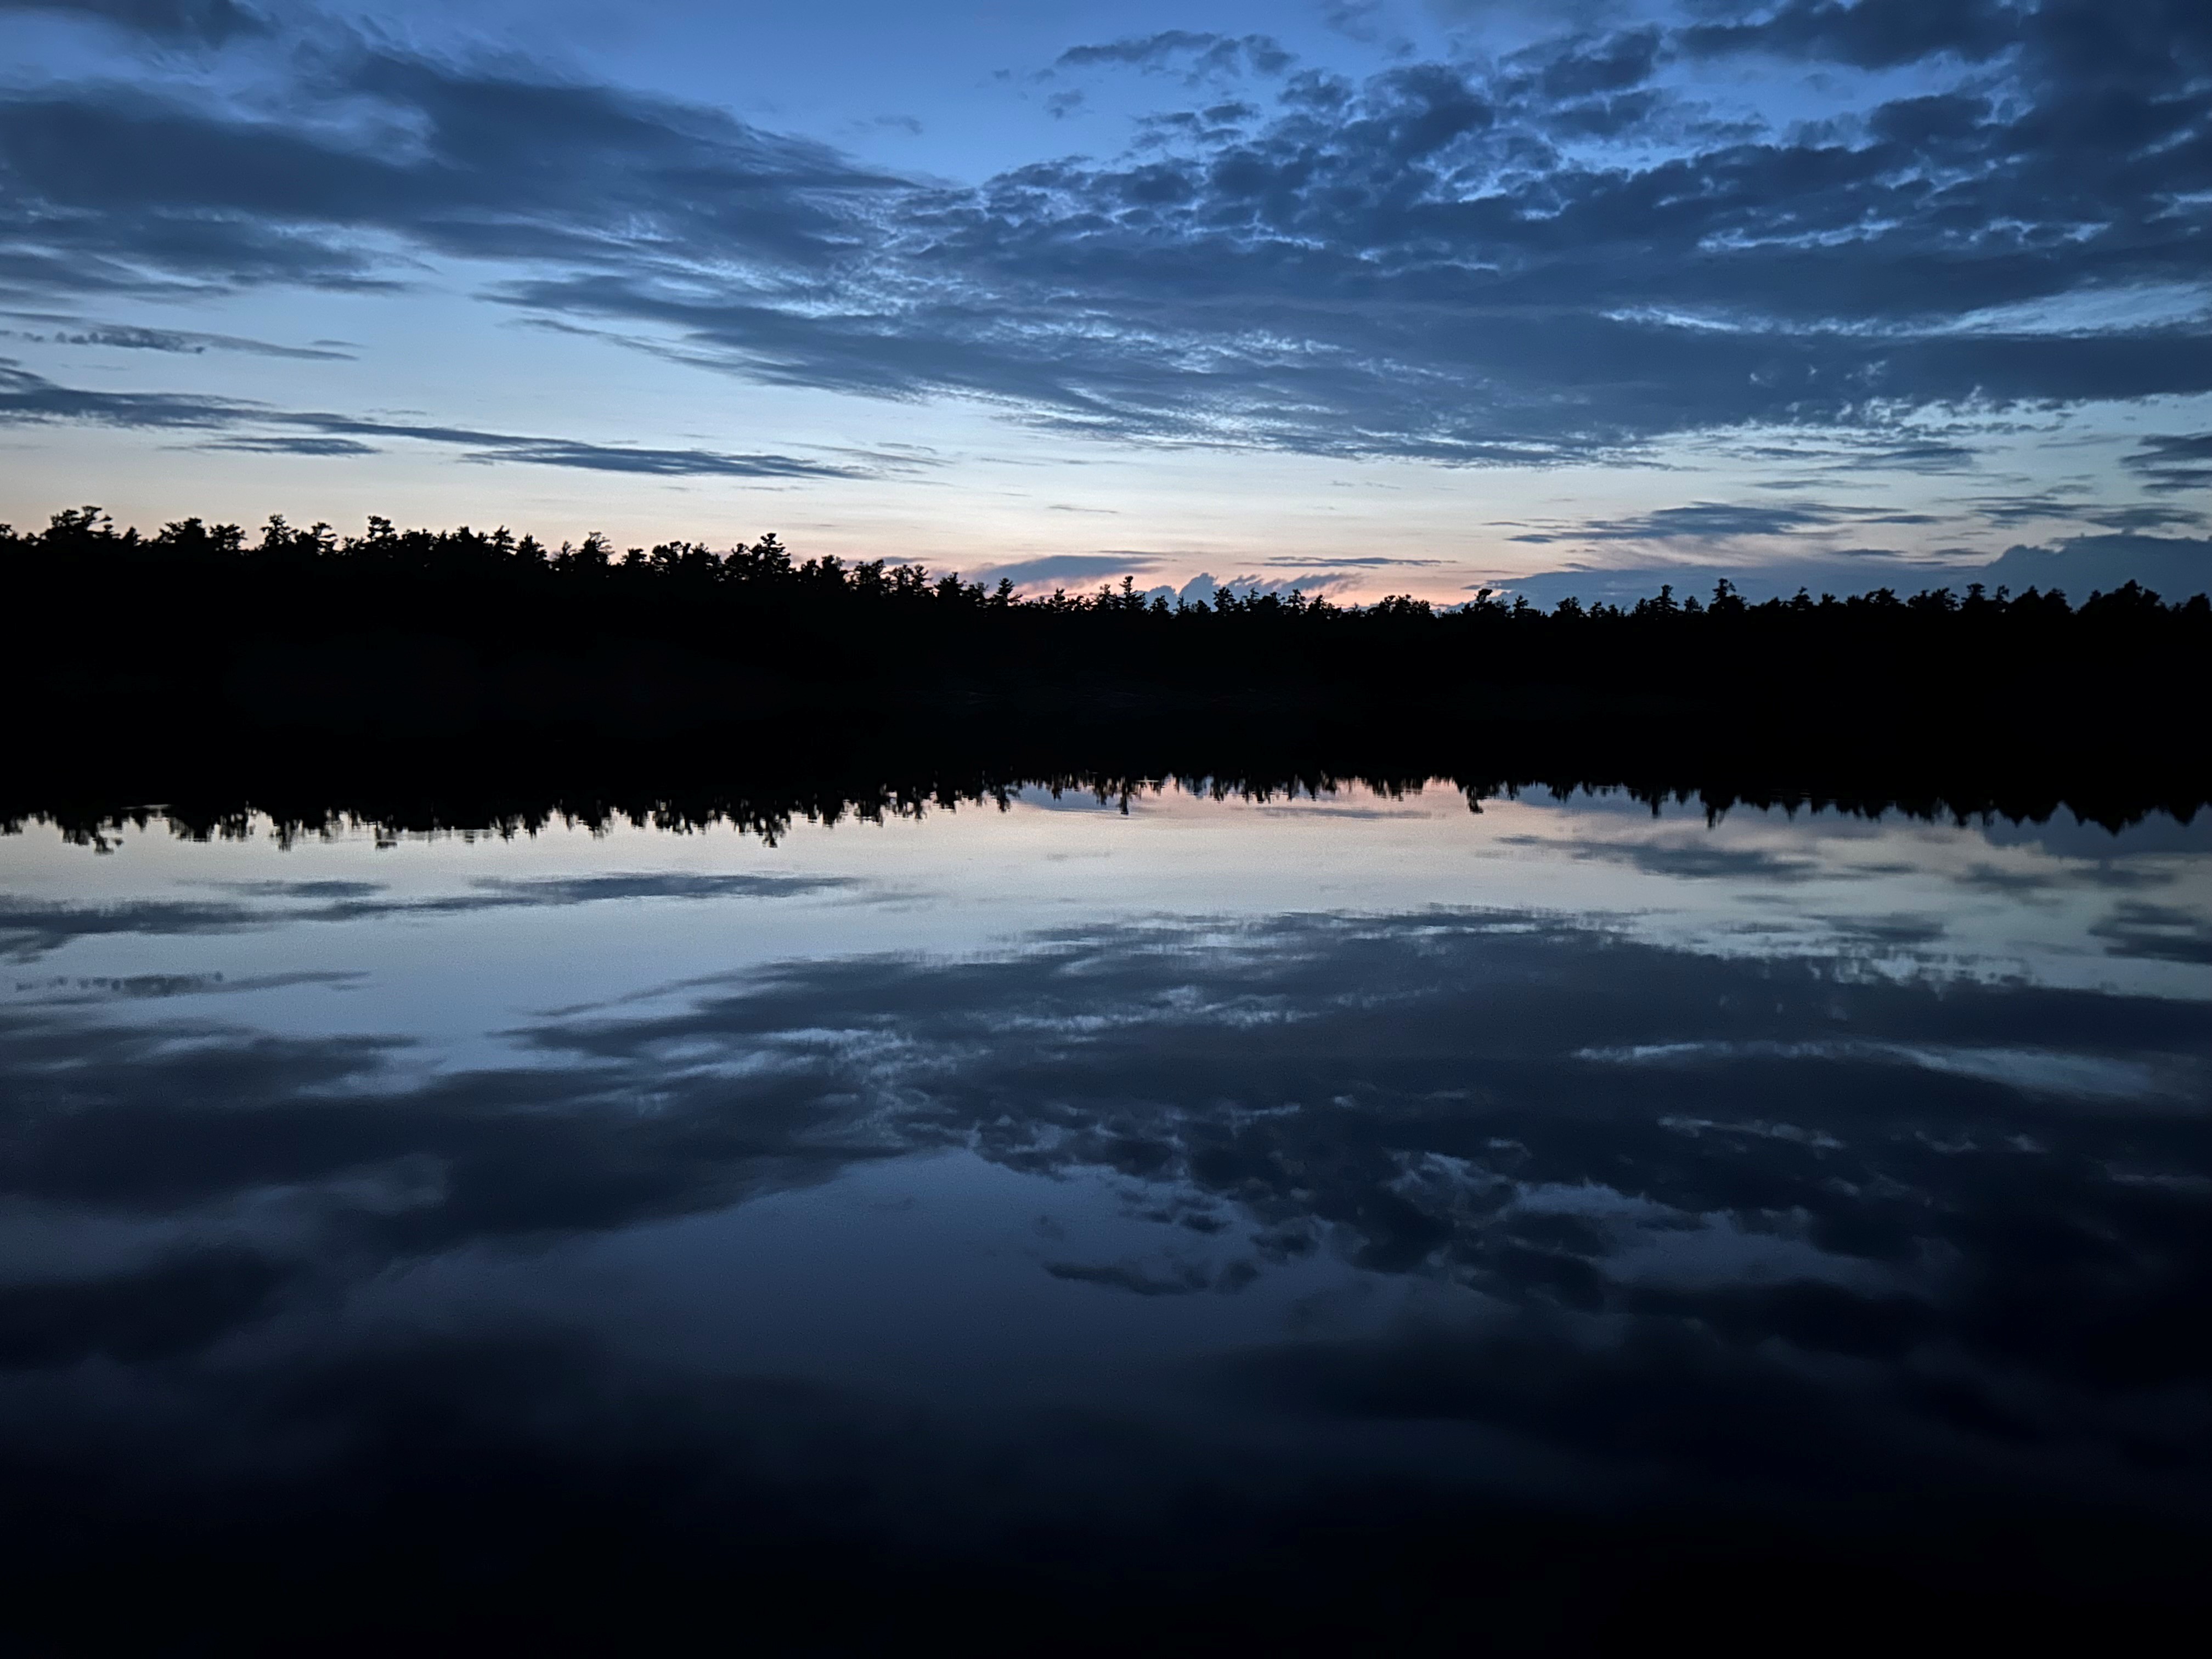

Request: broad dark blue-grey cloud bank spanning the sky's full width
left=0, top=0, right=2212, bottom=473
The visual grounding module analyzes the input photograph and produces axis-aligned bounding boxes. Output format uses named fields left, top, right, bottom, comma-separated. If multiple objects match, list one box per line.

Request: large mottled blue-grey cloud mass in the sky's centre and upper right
left=489, top=6, right=2212, bottom=467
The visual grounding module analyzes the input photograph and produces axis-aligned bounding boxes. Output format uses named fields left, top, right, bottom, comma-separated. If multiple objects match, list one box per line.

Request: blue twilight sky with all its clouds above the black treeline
left=0, top=0, right=2212, bottom=604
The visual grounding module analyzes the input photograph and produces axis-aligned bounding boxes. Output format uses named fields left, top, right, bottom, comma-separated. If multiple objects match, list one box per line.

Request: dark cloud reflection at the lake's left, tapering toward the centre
left=0, top=1011, right=849, bottom=1248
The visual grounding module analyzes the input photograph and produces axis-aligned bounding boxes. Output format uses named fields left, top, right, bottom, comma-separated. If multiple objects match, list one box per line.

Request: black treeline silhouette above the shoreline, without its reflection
left=17, top=506, right=2212, bottom=692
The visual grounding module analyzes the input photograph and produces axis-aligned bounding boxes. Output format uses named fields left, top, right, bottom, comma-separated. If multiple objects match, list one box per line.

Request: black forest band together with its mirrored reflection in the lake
left=0, top=506, right=2212, bottom=823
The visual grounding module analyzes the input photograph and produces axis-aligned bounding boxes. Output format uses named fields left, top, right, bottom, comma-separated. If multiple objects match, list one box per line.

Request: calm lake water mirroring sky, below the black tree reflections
left=0, top=787, right=2212, bottom=1652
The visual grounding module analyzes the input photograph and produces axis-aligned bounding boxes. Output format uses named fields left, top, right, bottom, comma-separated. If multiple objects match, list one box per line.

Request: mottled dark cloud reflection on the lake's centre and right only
left=533, top=916, right=2203, bottom=1358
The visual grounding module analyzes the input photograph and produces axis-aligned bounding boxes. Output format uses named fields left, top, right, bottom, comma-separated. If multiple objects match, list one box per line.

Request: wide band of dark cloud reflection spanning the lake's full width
left=0, top=911, right=2212, bottom=1369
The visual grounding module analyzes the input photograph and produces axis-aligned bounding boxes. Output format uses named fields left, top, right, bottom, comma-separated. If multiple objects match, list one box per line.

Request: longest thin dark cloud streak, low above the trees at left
left=0, top=358, right=880, bottom=478
